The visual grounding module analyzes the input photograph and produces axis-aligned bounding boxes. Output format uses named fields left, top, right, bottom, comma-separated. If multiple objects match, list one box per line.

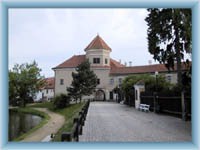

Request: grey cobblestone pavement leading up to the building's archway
left=80, top=102, right=192, bottom=142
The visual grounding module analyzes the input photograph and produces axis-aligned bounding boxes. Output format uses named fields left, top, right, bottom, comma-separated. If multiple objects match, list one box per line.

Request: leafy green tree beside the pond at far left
left=9, top=61, right=44, bottom=107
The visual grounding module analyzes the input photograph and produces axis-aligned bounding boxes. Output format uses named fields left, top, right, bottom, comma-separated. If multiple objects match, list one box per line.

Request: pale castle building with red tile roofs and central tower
left=53, top=35, right=183, bottom=100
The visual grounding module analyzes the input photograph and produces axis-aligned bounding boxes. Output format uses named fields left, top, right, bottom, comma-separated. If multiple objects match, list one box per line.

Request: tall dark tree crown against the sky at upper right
left=145, top=9, right=192, bottom=85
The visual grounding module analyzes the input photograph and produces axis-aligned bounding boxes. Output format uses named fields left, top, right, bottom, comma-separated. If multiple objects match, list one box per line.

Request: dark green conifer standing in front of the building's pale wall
left=67, top=60, right=97, bottom=101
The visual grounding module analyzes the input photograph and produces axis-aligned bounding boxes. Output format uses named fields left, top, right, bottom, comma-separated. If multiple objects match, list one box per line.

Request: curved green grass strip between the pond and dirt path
left=12, top=108, right=50, bottom=141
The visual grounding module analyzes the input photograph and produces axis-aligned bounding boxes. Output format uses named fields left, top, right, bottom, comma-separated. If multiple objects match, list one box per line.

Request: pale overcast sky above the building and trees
left=9, top=9, right=155, bottom=77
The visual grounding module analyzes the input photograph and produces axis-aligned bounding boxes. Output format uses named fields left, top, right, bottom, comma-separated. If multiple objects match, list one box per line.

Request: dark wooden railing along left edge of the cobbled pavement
left=61, top=101, right=90, bottom=142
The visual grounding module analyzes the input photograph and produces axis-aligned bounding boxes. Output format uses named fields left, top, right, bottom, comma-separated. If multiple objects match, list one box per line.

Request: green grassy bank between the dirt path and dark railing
left=28, top=102, right=86, bottom=142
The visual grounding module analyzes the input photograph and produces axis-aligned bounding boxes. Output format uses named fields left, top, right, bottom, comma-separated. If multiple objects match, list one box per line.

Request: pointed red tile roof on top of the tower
left=85, top=35, right=111, bottom=51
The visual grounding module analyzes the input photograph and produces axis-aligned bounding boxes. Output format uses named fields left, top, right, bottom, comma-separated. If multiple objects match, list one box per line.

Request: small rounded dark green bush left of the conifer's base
left=53, top=94, right=70, bottom=109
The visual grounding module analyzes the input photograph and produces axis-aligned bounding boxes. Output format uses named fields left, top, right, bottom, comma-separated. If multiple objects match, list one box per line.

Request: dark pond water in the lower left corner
left=9, top=110, right=42, bottom=141
